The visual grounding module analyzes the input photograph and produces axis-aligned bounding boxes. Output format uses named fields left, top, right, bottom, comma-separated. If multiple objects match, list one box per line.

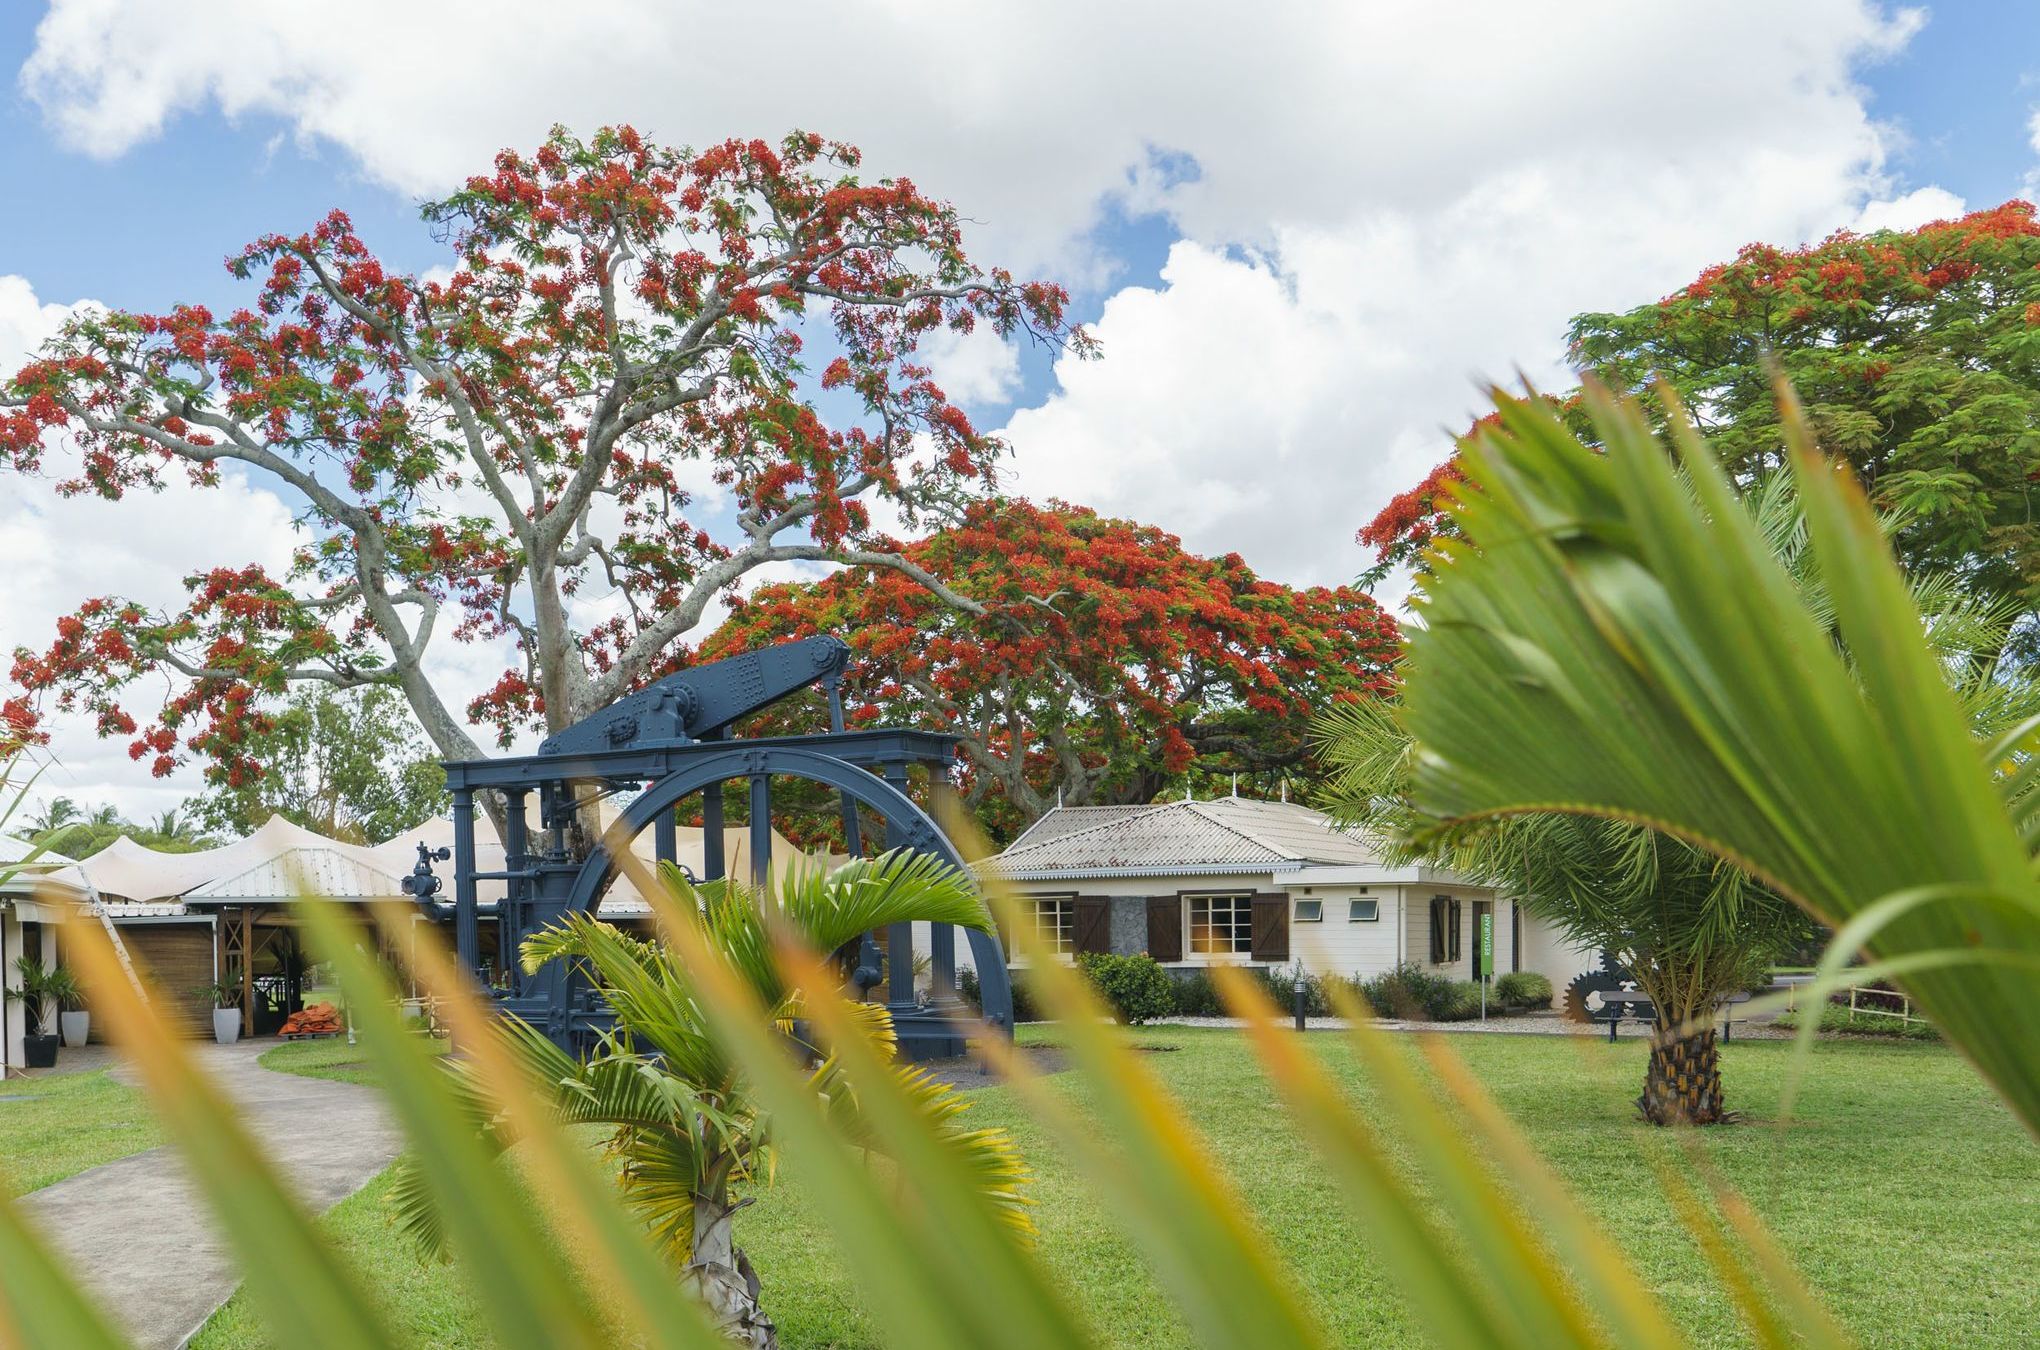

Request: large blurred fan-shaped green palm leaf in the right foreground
left=1406, top=377, right=2040, bottom=1128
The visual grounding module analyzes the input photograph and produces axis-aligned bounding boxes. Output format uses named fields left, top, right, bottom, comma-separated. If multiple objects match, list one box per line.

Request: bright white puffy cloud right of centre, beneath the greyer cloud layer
left=1008, top=145, right=1946, bottom=581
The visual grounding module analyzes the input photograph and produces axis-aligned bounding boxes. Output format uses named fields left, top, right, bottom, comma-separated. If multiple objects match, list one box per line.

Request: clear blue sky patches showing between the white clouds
left=0, top=0, right=2040, bottom=344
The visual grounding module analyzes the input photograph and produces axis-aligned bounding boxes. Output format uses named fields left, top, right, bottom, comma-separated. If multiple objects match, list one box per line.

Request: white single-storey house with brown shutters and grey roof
left=959, top=797, right=1593, bottom=987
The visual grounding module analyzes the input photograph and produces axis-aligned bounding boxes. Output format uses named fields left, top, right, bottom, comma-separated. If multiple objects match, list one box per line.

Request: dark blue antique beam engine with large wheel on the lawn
left=420, top=638, right=1012, bottom=1058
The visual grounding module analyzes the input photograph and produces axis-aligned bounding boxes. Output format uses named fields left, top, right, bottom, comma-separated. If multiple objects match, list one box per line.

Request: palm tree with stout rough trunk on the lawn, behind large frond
left=1318, top=471, right=2040, bottom=1126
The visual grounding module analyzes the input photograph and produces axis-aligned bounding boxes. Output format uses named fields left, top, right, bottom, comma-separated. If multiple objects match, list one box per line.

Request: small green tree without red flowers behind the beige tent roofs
left=194, top=685, right=447, bottom=844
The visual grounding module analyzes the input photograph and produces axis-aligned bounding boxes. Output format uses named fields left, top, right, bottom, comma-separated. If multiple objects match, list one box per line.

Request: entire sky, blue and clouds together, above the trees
left=0, top=0, right=2040, bottom=810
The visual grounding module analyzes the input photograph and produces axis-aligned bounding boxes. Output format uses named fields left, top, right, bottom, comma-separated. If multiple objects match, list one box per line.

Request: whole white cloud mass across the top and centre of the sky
left=3, top=0, right=1960, bottom=815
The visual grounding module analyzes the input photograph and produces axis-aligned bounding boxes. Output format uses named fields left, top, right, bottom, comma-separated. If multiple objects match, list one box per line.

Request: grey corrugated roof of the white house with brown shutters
left=991, top=797, right=1375, bottom=875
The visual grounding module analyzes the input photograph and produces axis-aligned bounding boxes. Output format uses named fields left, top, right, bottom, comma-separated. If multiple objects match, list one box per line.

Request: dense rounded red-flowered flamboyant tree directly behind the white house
left=702, top=500, right=1399, bottom=832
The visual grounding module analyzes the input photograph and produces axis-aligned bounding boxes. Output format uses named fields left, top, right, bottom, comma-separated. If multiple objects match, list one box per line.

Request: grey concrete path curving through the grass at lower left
left=20, top=1040, right=400, bottom=1350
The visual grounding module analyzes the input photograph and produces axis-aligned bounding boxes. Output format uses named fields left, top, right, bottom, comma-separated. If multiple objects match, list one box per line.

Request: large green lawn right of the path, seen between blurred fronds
left=194, top=1028, right=2040, bottom=1350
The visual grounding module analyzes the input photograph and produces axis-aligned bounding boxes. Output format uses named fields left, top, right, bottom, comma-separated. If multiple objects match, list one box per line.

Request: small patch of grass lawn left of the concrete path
left=0, top=1069, right=163, bottom=1195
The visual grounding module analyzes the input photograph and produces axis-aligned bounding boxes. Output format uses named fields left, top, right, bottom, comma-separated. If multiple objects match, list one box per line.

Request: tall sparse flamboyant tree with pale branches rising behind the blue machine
left=0, top=128, right=1089, bottom=785
